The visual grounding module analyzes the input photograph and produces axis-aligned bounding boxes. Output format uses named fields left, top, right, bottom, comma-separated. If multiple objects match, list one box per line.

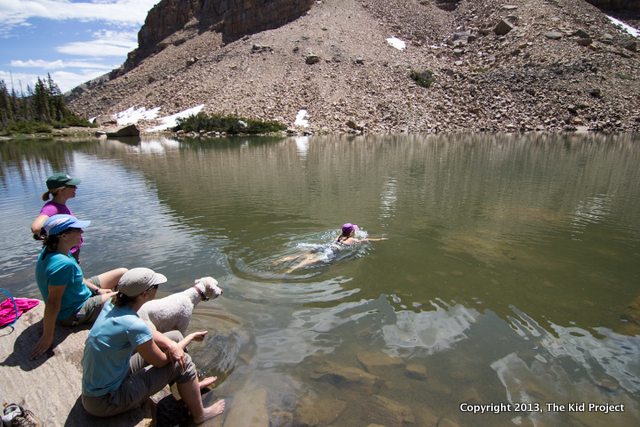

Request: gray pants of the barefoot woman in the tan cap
left=82, top=331, right=197, bottom=417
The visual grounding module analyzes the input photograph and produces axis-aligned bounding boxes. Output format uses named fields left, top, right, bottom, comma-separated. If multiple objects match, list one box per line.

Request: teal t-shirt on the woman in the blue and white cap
left=36, top=248, right=93, bottom=320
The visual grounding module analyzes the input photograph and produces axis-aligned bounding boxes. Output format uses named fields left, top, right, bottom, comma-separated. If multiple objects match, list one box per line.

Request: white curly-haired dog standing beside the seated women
left=138, top=277, right=222, bottom=335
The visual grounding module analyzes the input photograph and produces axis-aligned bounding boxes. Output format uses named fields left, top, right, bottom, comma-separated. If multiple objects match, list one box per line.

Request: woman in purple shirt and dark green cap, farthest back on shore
left=31, top=173, right=82, bottom=263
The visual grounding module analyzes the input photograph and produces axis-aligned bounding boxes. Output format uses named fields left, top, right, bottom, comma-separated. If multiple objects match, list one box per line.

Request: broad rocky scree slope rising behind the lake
left=69, top=0, right=640, bottom=132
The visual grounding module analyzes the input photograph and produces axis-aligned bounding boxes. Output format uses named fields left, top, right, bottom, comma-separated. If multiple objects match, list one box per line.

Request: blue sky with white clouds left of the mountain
left=0, top=0, right=160, bottom=92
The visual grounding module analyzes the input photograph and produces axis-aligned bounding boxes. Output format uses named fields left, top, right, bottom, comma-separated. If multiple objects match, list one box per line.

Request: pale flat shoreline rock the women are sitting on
left=0, top=301, right=181, bottom=427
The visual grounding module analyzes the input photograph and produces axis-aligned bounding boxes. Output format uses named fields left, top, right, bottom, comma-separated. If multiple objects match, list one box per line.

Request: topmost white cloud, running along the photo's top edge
left=0, top=0, right=159, bottom=30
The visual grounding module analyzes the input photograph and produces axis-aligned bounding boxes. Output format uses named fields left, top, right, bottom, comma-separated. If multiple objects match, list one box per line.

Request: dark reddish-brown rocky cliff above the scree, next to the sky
left=124, top=0, right=315, bottom=71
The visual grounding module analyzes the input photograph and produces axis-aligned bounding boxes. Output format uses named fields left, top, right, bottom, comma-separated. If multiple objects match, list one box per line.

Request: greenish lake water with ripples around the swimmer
left=0, top=135, right=640, bottom=427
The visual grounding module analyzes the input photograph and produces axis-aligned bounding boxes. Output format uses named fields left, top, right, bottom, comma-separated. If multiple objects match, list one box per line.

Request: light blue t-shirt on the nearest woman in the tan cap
left=82, top=301, right=153, bottom=397
